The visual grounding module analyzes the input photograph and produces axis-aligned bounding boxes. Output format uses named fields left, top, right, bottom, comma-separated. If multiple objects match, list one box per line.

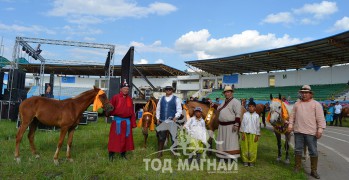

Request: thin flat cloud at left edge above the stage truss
left=0, top=23, right=56, bottom=34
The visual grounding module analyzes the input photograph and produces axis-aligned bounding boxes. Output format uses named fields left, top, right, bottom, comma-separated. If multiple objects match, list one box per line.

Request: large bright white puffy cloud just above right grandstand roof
left=175, top=29, right=302, bottom=59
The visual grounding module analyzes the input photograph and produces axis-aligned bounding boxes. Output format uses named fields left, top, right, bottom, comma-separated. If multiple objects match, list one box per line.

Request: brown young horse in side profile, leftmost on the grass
left=15, top=87, right=114, bottom=165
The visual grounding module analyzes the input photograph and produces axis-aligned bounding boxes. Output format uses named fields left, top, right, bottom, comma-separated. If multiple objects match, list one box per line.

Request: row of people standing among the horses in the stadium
left=108, top=82, right=324, bottom=178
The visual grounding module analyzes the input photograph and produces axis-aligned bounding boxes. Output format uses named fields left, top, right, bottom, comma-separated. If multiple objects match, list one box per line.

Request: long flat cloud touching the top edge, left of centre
left=48, top=0, right=177, bottom=18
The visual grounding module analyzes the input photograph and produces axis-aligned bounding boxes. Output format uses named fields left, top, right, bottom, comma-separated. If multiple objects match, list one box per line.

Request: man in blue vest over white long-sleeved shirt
left=156, top=86, right=182, bottom=157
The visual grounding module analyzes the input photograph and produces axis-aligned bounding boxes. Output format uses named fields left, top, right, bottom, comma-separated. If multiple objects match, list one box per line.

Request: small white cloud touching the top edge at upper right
left=294, top=1, right=338, bottom=19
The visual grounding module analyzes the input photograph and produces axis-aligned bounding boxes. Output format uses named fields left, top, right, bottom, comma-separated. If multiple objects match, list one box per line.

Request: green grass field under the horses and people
left=0, top=118, right=307, bottom=180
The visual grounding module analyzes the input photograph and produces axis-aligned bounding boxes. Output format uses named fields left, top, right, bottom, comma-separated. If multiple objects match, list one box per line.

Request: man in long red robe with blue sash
left=107, top=81, right=137, bottom=161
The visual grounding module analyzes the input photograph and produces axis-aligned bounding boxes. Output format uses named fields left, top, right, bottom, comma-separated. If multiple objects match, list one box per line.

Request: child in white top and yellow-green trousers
left=240, top=101, right=260, bottom=167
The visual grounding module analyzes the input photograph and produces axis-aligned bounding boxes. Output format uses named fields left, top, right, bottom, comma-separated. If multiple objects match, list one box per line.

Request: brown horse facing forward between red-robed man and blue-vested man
left=138, top=97, right=158, bottom=148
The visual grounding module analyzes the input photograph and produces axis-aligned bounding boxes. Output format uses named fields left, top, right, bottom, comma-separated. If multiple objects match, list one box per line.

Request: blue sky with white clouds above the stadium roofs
left=0, top=0, right=349, bottom=70
